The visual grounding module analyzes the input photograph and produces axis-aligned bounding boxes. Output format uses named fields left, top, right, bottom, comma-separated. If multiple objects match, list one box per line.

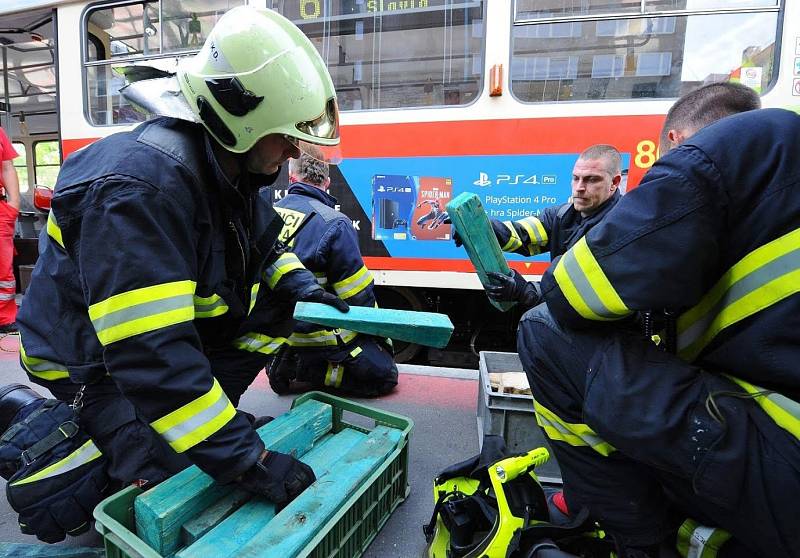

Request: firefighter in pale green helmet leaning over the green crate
left=3, top=7, right=347, bottom=540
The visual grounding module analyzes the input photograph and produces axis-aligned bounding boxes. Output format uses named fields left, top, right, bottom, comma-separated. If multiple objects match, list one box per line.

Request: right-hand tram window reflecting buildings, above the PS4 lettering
left=510, top=7, right=779, bottom=102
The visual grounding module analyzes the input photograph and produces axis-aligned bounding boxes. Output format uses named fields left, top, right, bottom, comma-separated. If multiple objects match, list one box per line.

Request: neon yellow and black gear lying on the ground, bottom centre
left=423, top=435, right=615, bottom=558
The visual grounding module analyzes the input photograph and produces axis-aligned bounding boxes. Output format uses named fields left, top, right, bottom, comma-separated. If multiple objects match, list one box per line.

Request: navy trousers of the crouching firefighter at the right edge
left=517, top=304, right=800, bottom=557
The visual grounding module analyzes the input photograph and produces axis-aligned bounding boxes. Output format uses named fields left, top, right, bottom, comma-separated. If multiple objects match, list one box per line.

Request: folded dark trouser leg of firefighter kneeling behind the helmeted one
left=281, top=335, right=397, bottom=397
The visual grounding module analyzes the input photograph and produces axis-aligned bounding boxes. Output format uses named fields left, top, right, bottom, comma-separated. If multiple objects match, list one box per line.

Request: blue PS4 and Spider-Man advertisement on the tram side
left=340, top=153, right=630, bottom=261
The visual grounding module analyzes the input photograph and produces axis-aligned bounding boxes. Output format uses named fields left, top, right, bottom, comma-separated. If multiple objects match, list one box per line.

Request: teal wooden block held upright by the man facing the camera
left=447, top=192, right=515, bottom=312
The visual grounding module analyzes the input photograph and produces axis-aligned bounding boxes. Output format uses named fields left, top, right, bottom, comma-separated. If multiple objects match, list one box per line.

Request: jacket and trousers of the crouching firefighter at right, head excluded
left=518, top=98, right=800, bottom=557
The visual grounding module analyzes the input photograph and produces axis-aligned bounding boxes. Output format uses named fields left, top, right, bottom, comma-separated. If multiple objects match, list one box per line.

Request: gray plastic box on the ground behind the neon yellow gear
left=478, top=351, right=561, bottom=483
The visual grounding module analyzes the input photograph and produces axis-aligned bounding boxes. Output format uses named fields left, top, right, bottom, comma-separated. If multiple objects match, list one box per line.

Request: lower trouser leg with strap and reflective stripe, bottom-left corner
left=0, top=390, right=109, bottom=543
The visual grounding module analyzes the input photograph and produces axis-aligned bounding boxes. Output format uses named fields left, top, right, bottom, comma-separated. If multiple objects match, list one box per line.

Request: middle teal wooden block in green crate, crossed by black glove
left=175, top=428, right=367, bottom=558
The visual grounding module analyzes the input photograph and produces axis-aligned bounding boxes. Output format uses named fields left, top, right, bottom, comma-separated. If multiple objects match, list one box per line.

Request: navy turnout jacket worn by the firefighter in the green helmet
left=19, top=118, right=319, bottom=482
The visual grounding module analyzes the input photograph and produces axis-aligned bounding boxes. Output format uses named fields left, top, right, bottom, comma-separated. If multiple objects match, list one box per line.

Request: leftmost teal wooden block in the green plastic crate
left=134, top=401, right=333, bottom=556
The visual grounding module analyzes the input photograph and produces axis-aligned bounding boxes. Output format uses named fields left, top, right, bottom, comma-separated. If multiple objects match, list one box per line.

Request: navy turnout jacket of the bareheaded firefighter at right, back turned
left=542, top=109, right=800, bottom=424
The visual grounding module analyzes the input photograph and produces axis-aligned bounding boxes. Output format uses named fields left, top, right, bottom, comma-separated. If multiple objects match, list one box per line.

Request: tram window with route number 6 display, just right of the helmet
left=267, top=0, right=486, bottom=110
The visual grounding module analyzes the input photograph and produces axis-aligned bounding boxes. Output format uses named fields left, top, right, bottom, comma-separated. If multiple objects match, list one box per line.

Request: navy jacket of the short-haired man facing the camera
left=491, top=190, right=622, bottom=261
